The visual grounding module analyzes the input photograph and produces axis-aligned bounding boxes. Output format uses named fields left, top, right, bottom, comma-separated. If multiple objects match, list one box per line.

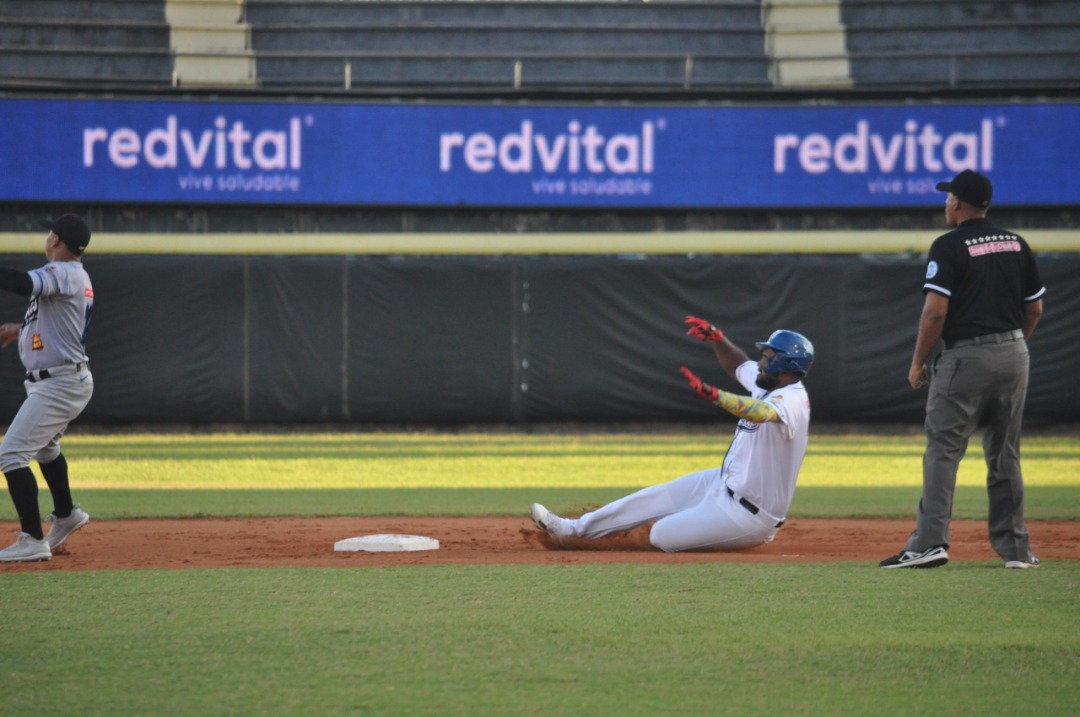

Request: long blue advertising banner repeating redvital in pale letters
left=0, top=99, right=1080, bottom=208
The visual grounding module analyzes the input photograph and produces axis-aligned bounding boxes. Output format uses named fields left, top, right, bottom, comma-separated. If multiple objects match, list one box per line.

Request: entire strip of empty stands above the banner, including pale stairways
left=0, top=0, right=1080, bottom=96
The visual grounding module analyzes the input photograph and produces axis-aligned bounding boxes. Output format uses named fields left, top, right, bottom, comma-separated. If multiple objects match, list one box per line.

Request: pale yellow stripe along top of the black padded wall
left=0, top=229, right=1080, bottom=255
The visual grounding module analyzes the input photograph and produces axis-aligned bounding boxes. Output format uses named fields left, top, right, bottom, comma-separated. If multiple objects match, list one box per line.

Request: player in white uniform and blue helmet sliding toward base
left=530, top=316, right=813, bottom=552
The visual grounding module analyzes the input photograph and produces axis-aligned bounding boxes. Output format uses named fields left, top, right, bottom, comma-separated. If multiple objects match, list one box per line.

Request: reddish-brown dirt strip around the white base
left=0, top=517, right=1080, bottom=573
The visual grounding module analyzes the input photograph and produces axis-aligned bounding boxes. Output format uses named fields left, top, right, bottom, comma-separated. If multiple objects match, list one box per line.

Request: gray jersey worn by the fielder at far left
left=18, top=261, right=94, bottom=370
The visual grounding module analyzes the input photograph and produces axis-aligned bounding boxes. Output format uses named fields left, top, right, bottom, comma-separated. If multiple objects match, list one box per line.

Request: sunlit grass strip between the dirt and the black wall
left=0, top=427, right=1080, bottom=519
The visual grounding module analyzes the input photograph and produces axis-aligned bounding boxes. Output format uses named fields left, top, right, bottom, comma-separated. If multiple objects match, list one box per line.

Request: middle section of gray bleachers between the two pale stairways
left=247, top=0, right=769, bottom=89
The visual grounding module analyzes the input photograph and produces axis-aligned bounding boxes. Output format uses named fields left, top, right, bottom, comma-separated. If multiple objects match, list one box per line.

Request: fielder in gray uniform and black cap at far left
left=0, top=214, right=94, bottom=563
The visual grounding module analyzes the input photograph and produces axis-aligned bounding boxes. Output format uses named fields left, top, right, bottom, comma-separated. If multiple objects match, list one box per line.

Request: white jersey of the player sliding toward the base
left=721, top=361, right=810, bottom=519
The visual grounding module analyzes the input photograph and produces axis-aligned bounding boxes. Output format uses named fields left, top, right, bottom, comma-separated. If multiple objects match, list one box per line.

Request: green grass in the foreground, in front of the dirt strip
left=0, top=563, right=1080, bottom=717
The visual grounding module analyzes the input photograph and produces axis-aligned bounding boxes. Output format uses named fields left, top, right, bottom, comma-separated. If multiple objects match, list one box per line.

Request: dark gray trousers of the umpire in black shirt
left=905, top=339, right=1031, bottom=562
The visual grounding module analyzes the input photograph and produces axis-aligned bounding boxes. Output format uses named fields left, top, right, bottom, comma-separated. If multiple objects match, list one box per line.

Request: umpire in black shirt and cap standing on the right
left=880, top=170, right=1047, bottom=568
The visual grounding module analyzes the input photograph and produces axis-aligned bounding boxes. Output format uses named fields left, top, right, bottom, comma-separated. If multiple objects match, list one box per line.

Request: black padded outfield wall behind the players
left=0, top=255, right=1080, bottom=425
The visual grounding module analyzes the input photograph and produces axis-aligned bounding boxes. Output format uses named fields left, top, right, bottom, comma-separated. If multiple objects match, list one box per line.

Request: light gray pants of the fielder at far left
left=0, top=369, right=94, bottom=473
